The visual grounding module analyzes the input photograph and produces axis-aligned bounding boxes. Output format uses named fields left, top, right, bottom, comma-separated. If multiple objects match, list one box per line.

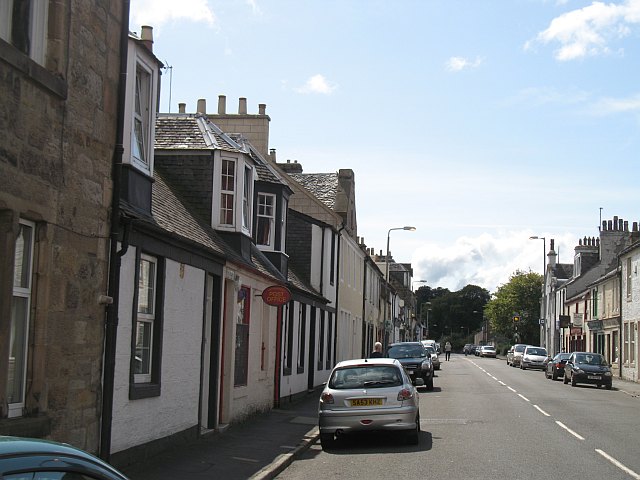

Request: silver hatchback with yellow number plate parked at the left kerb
left=318, top=358, right=423, bottom=449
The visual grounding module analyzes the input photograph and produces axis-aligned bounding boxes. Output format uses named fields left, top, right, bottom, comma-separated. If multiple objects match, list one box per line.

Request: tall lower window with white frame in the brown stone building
left=7, top=220, right=35, bottom=417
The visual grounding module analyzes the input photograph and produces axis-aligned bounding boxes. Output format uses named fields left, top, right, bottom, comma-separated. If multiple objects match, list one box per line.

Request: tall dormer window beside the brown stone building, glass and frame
left=131, top=62, right=153, bottom=171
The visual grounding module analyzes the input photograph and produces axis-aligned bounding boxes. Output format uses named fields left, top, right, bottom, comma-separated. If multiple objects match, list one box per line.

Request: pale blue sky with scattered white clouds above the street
left=130, top=0, right=640, bottom=292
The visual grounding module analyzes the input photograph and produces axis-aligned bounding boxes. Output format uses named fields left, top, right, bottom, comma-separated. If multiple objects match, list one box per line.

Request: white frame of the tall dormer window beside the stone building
left=131, top=56, right=154, bottom=173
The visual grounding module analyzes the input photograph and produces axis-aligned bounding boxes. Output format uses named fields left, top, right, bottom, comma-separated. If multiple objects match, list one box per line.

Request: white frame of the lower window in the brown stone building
left=7, top=219, right=36, bottom=418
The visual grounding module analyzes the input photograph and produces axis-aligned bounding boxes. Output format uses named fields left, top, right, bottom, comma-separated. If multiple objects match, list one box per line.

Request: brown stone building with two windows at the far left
left=0, top=0, right=129, bottom=451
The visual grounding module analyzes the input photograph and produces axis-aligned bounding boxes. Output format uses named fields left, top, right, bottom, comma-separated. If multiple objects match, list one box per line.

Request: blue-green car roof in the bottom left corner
left=0, top=436, right=127, bottom=480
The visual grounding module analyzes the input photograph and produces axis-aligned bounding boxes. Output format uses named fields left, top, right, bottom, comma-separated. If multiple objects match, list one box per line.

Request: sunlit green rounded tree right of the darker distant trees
left=484, top=270, right=542, bottom=344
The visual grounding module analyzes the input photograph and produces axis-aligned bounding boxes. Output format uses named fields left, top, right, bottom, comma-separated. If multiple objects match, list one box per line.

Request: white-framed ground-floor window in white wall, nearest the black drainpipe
left=134, top=254, right=157, bottom=383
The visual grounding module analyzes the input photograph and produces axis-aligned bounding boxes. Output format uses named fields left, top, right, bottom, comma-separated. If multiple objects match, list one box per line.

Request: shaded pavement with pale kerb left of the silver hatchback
left=121, top=391, right=320, bottom=480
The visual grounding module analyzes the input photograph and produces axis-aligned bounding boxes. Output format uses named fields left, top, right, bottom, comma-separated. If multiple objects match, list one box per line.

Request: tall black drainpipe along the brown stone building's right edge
left=100, top=0, right=130, bottom=461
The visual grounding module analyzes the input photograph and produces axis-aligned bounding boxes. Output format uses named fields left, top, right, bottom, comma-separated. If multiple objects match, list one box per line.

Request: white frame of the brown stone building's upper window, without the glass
left=0, top=0, right=49, bottom=66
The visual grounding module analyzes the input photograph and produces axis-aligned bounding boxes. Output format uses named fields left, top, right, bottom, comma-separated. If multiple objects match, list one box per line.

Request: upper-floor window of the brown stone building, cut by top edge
left=0, top=0, right=49, bottom=65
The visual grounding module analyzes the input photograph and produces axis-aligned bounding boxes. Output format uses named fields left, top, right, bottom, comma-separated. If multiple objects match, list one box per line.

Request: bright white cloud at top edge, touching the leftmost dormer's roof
left=129, top=0, right=216, bottom=31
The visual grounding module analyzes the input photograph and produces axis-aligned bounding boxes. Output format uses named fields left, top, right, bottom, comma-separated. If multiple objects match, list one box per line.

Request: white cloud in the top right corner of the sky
left=525, top=0, right=640, bottom=61
